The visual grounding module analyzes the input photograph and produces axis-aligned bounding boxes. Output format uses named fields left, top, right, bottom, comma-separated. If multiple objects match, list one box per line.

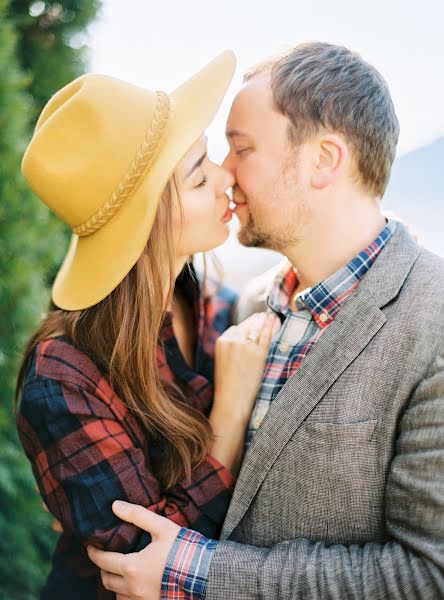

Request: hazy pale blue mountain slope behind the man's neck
left=383, top=138, right=444, bottom=256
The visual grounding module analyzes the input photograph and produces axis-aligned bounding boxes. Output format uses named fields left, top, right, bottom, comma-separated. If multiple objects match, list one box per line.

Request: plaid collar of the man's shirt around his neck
left=267, top=220, right=396, bottom=329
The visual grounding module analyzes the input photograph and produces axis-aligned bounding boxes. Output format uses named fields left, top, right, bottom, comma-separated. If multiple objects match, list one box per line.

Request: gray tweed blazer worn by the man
left=206, top=224, right=444, bottom=600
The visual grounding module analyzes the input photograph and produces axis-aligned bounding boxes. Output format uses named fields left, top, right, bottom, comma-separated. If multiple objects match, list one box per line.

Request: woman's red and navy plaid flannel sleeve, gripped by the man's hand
left=17, top=377, right=234, bottom=552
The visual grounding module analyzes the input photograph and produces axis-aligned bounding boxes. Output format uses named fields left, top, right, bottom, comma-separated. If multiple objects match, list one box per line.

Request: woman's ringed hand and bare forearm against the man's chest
left=210, top=313, right=277, bottom=474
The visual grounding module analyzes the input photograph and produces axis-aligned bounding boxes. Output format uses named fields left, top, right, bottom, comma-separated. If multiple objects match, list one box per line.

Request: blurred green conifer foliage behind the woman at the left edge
left=0, top=0, right=98, bottom=600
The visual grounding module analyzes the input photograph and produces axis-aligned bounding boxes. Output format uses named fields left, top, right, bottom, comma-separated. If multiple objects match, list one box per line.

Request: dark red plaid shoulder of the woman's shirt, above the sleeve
left=24, top=336, right=103, bottom=390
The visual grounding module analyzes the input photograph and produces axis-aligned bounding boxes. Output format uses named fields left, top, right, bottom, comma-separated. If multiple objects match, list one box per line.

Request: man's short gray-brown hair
left=245, top=42, right=399, bottom=197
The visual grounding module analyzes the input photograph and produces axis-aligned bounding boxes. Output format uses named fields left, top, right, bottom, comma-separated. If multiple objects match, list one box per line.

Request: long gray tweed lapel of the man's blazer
left=221, top=224, right=419, bottom=539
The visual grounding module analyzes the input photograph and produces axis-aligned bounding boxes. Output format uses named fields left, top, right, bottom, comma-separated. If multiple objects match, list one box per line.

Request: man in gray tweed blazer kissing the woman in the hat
left=89, top=43, right=444, bottom=600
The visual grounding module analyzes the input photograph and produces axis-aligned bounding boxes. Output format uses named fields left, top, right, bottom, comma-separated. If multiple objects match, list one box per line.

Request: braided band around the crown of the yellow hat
left=72, top=92, right=171, bottom=237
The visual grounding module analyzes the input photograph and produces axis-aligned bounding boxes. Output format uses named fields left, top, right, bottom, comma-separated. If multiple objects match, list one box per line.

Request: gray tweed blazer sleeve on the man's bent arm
left=206, top=354, right=444, bottom=600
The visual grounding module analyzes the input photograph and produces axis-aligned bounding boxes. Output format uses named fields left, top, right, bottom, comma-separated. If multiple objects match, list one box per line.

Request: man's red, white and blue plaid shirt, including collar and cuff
left=160, top=221, right=396, bottom=600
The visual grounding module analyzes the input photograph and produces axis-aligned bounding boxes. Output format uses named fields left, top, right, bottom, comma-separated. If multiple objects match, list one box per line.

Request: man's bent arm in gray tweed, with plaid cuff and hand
left=87, top=355, right=444, bottom=600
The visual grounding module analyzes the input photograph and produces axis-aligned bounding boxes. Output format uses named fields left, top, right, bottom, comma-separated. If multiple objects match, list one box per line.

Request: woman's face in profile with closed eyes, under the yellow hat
left=173, top=136, right=234, bottom=257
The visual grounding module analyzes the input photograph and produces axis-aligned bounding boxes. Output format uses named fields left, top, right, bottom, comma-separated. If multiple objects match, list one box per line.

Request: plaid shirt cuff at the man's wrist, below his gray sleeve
left=160, top=527, right=218, bottom=600
